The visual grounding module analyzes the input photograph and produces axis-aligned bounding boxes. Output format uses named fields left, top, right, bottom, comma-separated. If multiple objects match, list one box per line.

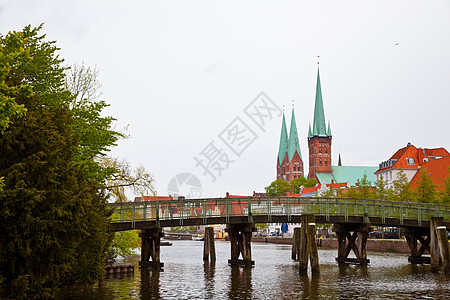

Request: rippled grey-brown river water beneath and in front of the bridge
left=59, top=241, right=450, bottom=299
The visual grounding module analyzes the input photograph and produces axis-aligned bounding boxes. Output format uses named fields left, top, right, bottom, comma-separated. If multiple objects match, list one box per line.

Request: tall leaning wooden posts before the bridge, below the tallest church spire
left=294, top=215, right=319, bottom=274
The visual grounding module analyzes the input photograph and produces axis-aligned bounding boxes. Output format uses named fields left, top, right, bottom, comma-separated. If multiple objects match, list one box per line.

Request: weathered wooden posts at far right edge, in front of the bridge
left=430, top=217, right=450, bottom=273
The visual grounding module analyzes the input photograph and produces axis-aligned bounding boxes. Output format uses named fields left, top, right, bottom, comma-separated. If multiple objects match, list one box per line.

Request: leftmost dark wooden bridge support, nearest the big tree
left=139, top=228, right=164, bottom=270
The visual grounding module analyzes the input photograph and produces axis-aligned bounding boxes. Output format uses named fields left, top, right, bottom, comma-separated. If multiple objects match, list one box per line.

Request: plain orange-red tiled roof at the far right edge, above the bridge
left=411, top=156, right=450, bottom=190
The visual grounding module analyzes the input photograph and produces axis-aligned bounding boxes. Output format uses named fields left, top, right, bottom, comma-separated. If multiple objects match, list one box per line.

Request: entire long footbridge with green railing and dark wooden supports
left=110, top=197, right=450, bottom=271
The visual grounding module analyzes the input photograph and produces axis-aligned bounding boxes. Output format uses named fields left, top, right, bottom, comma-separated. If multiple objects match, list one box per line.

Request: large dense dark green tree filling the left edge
left=0, top=26, right=116, bottom=298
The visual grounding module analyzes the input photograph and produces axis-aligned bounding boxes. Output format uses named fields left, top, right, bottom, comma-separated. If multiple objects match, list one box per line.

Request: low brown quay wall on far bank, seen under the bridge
left=252, top=237, right=410, bottom=254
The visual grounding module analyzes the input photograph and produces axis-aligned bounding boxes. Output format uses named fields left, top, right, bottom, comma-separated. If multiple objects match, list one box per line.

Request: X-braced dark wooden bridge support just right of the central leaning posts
left=334, top=223, right=370, bottom=265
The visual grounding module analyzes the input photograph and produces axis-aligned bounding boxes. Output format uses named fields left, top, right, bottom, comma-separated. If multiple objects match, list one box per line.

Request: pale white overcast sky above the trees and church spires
left=0, top=0, right=450, bottom=197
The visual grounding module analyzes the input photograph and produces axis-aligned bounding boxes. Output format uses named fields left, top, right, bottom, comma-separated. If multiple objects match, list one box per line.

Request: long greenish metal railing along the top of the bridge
left=110, top=197, right=450, bottom=225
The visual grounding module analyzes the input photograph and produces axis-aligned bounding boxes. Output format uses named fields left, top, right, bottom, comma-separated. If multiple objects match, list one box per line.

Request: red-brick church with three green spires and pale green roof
left=277, top=69, right=378, bottom=186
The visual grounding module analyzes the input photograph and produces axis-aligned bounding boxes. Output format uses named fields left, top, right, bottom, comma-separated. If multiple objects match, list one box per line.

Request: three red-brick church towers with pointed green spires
left=277, top=66, right=331, bottom=181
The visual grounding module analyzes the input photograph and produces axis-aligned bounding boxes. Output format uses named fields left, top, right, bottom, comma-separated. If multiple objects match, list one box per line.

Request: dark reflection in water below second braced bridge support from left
left=228, top=266, right=253, bottom=299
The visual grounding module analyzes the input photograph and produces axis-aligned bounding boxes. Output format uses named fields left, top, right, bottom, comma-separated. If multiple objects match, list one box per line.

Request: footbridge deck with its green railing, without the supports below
left=110, top=197, right=450, bottom=231
